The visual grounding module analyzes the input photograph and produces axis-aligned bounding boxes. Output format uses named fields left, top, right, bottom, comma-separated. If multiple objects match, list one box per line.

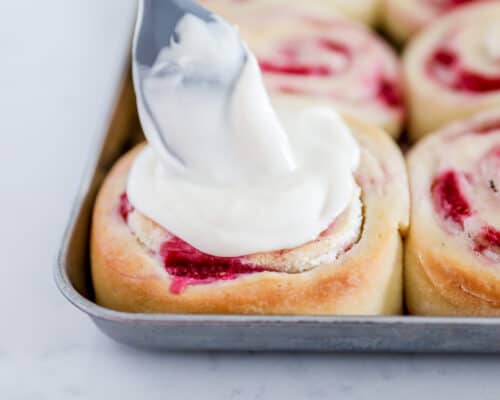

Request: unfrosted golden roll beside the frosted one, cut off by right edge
left=405, top=110, right=500, bottom=316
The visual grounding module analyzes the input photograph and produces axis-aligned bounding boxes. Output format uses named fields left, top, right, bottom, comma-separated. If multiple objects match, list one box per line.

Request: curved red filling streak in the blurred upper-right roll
left=426, top=47, right=500, bottom=94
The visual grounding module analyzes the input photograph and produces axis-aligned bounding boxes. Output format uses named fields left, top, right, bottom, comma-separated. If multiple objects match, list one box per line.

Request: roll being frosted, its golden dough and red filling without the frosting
left=91, top=115, right=409, bottom=315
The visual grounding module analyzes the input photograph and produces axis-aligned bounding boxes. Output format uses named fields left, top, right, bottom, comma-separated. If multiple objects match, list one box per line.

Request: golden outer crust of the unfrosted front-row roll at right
left=404, top=111, right=500, bottom=316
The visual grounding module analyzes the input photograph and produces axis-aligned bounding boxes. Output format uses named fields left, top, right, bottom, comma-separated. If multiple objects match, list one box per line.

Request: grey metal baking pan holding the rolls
left=55, top=69, right=500, bottom=353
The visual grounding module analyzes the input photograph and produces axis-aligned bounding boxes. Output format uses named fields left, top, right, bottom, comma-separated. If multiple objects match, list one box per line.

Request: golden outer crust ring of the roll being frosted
left=91, top=115, right=409, bottom=315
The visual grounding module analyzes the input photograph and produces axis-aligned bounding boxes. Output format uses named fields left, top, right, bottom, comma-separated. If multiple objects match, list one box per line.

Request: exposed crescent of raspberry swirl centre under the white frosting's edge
left=121, top=188, right=362, bottom=294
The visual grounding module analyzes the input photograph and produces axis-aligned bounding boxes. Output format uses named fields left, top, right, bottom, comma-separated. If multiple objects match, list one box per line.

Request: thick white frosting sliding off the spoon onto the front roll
left=125, top=15, right=361, bottom=257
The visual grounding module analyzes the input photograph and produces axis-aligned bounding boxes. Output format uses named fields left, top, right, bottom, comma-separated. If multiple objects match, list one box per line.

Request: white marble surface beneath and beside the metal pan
left=0, top=0, right=500, bottom=400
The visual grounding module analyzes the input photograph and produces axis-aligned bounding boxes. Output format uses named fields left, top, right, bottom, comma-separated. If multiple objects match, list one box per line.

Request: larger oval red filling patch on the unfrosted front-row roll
left=432, top=170, right=472, bottom=227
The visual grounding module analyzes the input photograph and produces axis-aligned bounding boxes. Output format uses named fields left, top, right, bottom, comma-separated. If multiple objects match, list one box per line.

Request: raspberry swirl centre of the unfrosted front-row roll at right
left=431, top=136, right=500, bottom=263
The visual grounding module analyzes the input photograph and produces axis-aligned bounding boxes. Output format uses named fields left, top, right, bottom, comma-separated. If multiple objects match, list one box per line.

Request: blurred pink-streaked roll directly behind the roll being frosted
left=198, top=1, right=404, bottom=136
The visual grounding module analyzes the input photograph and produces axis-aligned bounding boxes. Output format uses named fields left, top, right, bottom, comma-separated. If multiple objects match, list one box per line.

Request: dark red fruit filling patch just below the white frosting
left=160, top=237, right=264, bottom=294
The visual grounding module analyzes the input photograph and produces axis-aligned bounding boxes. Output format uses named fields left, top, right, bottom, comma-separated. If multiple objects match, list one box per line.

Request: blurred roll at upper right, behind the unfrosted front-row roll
left=404, top=2, right=500, bottom=139
